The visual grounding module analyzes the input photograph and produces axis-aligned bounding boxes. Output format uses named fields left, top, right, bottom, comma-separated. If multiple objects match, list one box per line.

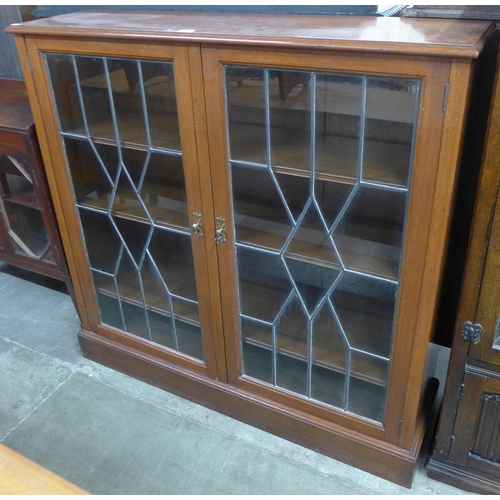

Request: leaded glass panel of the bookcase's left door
left=30, top=40, right=215, bottom=376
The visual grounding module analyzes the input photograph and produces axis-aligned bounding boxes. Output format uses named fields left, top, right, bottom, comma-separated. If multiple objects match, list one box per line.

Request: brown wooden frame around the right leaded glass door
left=202, top=45, right=458, bottom=450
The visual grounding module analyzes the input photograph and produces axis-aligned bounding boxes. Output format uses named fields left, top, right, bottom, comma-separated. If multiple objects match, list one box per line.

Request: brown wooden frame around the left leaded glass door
left=17, top=37, right=224, bottom=379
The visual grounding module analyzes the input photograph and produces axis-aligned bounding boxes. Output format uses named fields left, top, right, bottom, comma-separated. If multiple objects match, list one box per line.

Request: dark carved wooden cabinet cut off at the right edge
left=427, top=53, right=500, bottom=488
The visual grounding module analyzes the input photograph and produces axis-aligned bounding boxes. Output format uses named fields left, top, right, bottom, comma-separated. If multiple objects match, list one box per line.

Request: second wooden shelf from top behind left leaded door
left=78, top=183, right=190, bottom=233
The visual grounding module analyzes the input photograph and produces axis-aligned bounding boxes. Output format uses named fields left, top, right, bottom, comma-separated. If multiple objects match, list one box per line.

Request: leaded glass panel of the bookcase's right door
left=205, top=46, right=450, bottom=438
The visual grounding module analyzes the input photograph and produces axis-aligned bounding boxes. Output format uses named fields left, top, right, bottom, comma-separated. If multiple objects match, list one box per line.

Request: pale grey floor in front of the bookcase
left=0, top=263, right=466, bottom=495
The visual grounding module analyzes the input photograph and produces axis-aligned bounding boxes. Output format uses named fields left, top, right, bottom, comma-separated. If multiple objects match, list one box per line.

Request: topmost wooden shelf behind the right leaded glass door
left=230, top=123, right=411, bottom=189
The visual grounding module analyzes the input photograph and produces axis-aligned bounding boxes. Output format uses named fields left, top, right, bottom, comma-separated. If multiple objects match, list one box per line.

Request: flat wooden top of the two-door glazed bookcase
left=7, top=11, right=494, bottom=58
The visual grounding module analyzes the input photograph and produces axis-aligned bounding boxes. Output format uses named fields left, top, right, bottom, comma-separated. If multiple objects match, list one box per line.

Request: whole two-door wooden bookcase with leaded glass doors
left=9, top=12, right=494, bottom=486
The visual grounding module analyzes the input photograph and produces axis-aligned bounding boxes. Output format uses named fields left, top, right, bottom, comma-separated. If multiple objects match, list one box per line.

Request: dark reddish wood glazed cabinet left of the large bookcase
left=0, top=79, right=72, bottom=293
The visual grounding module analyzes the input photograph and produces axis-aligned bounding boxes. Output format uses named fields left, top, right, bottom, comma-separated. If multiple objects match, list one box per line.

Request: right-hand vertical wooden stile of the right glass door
left=376, top=62, right=450, bottom=449
